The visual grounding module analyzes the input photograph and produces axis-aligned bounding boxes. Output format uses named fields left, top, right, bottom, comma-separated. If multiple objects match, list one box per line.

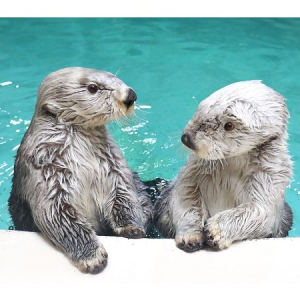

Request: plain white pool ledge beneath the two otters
left=0, top=230, right=300, bottom=286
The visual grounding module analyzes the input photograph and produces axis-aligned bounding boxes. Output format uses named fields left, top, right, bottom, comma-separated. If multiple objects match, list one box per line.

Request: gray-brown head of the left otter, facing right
left=36, top=67, right=137, bottom=127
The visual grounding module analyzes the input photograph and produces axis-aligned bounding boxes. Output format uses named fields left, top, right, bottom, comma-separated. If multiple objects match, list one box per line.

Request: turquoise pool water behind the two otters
left=0, top=18, right=300, bottom=236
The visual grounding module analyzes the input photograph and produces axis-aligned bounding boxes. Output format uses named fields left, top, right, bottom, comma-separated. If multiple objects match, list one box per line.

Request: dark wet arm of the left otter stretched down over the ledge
left=28, top=164, right=107, bottom=273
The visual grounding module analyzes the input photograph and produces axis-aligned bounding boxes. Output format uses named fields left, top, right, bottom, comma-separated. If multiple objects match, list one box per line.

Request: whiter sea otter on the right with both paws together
left=154, top=81, right=293, bottom=252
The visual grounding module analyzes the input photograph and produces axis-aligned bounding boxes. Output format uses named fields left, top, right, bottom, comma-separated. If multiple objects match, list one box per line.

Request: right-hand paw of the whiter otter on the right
left=203, top=221, right=232, bottom=250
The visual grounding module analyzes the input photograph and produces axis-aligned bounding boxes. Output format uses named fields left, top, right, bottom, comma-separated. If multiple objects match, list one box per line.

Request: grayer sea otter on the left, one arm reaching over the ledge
left=9, top=68, right=152, bottom=273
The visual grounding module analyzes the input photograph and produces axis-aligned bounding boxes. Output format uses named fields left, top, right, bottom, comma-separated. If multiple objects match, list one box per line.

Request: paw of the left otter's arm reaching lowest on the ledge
left=73, top=245, right=108, bottom=274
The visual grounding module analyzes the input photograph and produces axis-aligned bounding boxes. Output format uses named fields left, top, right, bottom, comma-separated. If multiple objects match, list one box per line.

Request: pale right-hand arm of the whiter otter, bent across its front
left=205, top=172, right=285, bottom=249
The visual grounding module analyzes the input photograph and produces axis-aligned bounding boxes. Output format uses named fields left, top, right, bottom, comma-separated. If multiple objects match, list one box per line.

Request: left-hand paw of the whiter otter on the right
left=175, top=231, right=205, bottom=252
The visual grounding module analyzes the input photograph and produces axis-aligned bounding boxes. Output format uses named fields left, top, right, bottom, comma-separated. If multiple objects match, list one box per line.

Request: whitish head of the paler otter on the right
left=181, top=80, right=289, bottom=160
